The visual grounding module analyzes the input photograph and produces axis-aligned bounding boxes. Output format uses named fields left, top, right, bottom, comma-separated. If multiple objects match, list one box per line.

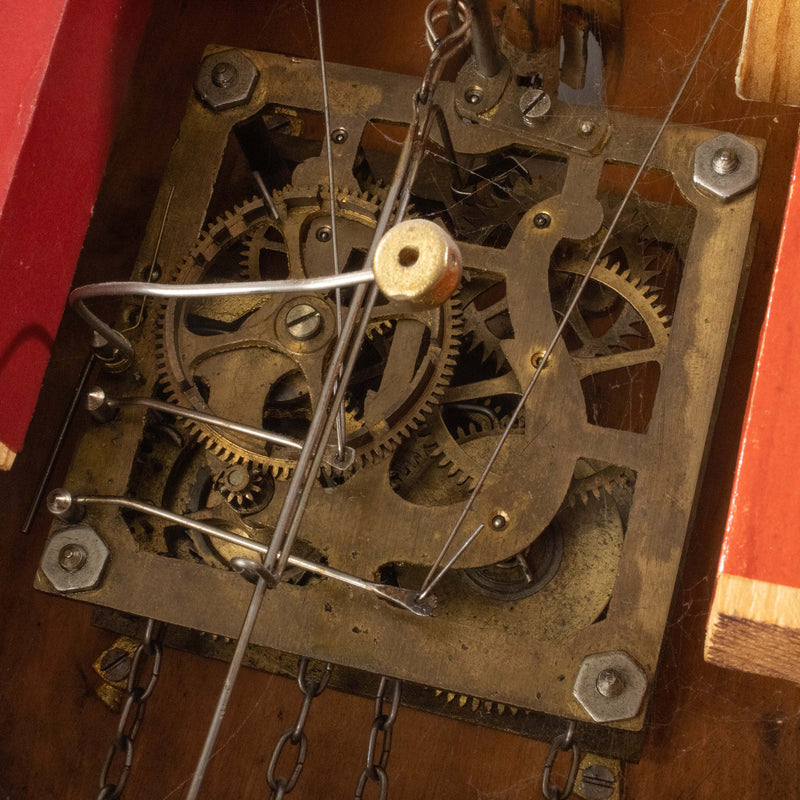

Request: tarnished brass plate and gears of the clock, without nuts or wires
left=37, top=45, right=759, bottom=751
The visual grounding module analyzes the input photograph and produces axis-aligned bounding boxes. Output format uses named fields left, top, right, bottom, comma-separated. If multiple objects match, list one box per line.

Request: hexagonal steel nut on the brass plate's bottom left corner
left=41, top=525, right=110, bottom=592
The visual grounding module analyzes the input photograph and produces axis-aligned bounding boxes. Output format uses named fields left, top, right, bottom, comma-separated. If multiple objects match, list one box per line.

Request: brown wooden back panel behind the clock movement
left=0, top=0, right=800, bottom=800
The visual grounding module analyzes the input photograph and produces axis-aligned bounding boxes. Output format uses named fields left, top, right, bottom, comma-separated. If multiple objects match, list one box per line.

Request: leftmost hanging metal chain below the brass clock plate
left=97, top=619, right=163, bottom=800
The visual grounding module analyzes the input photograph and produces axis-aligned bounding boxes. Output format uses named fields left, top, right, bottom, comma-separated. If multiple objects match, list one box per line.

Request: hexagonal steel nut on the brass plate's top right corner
left=693, top=133, right=758, bottom=200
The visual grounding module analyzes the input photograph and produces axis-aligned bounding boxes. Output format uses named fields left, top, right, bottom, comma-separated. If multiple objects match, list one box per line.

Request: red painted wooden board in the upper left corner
left=0, top=0, right=150, bottom=452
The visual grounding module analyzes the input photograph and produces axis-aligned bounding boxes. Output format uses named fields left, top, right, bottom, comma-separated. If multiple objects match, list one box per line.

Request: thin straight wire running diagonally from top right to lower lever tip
left=420, top=0, right=729, bottom=600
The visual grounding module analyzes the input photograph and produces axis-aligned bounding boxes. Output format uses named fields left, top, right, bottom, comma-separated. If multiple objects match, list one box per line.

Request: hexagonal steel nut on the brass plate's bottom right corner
left=572, top=650, right=647, bottom=722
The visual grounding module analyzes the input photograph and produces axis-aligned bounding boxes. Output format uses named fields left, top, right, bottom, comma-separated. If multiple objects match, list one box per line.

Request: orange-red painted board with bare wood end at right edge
left=706, top=128, right=800, bottom=682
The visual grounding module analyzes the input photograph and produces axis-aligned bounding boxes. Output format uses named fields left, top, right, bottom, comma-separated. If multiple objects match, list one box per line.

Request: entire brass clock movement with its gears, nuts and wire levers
left=15, top=3, right=784, bottom=800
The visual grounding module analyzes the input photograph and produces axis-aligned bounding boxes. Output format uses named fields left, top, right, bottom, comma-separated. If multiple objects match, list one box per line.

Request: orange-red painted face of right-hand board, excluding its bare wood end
left=719, top=131, right=800, bottom=588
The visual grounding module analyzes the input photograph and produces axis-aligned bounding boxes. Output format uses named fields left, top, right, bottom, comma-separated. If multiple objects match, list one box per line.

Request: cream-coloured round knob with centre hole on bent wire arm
left=372, top=219, right=462, bottom=308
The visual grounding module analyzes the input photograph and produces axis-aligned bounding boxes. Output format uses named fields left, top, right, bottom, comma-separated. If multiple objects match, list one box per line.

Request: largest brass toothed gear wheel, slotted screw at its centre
left=156, top=186, right=462, bottom=479
